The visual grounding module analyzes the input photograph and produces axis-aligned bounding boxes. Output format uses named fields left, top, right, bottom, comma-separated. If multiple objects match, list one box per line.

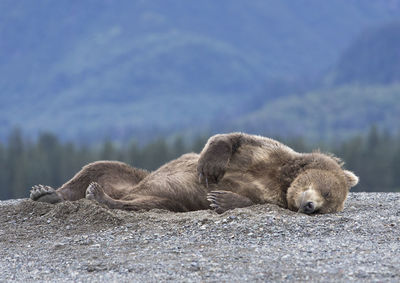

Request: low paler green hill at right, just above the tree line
left=230, top=84, right=400, bottom=142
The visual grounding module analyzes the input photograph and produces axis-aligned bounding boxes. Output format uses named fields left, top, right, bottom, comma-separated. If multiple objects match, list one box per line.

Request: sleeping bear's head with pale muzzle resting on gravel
left=287, top=157, right=358, bottom=214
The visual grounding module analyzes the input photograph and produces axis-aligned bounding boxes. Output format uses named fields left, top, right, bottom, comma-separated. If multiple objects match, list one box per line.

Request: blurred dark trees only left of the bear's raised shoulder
left=0, top=129, right=206, bottom=199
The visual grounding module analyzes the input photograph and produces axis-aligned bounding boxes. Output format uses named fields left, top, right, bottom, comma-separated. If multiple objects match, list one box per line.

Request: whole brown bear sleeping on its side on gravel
left=30, top=132, right=358, bottom=214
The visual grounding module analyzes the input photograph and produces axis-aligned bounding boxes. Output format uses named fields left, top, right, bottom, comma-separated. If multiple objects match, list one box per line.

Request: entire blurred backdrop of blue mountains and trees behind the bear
left=0, top=0, right=400, bottom=199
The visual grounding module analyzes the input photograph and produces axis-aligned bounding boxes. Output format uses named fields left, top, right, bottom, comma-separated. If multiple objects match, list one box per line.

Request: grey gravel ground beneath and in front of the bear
left=0, top=193, right=400, bottom=282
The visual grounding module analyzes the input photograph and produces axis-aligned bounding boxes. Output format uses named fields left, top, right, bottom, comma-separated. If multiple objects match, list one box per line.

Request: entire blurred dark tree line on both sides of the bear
left=0, top=127, right=400, bottom=199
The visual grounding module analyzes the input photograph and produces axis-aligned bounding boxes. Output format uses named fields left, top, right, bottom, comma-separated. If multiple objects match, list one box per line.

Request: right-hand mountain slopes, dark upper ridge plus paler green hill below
left=225, top=22, right=400, bottom=141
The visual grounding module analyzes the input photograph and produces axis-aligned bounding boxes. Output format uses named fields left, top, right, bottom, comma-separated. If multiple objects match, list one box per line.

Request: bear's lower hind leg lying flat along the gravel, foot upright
left=86, top=182, right=188, bottom=212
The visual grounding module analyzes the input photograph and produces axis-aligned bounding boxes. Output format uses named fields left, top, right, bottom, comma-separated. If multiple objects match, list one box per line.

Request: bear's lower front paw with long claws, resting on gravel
left=207, top=191, right=254, bottom=213
